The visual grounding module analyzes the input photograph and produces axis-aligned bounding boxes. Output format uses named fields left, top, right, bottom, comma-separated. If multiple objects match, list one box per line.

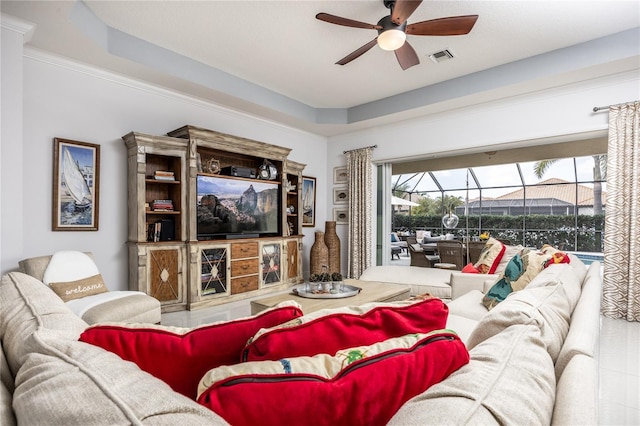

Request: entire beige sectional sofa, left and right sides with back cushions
left=0, top=258, right=601, bottom=426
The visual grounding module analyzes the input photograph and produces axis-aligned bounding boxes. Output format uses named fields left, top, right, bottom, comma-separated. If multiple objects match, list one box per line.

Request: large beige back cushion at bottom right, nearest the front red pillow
left=388, top=324, right=556, bottom=426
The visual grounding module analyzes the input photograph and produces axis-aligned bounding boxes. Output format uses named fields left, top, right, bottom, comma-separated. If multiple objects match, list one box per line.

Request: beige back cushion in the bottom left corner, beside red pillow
left=13, top=330, right=227, bottom=425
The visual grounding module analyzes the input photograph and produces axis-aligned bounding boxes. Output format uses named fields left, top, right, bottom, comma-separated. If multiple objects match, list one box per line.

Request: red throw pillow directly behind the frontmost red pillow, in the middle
left=242, top=298, right=449, bottom=361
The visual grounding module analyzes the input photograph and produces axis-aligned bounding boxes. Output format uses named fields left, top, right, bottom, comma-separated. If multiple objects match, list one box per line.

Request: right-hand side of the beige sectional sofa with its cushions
left=390, top=256, right=602, bottom=426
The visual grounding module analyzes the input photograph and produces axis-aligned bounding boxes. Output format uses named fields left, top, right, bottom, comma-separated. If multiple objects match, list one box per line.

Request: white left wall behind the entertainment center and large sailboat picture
left=2, top=50, right=327, bottom=289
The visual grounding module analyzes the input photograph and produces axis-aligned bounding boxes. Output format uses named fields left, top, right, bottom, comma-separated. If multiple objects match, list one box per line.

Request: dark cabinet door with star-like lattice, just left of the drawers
left=199, top=245, right=230, bottom=297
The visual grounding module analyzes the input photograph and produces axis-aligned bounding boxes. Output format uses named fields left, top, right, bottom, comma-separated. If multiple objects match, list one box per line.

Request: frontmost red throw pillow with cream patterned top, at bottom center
left=198, top=330, right=469, bottom=426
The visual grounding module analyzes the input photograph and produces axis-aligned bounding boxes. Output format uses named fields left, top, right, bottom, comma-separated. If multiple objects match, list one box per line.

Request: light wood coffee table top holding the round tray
left=251, top=279, right=410, bottom=315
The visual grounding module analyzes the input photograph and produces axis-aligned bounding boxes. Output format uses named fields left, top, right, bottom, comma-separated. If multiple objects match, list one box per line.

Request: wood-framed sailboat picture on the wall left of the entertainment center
left=53, top=138, right=100, bottom=231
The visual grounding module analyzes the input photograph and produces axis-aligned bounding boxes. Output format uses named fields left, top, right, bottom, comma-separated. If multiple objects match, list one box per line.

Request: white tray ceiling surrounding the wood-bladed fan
left=1, top=0, right=640, bottom=135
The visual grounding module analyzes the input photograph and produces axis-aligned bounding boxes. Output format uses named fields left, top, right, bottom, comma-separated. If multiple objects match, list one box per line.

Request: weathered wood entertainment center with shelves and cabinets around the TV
left=123, top=126, right=305, bottom=312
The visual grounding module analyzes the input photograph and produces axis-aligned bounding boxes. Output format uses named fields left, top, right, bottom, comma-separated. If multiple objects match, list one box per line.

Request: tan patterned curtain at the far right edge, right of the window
left=602, top=102, right=640, bottom=321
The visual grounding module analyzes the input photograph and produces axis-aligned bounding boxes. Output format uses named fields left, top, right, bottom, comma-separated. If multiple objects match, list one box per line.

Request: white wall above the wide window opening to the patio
left=327, top=70, right=640, bottom=264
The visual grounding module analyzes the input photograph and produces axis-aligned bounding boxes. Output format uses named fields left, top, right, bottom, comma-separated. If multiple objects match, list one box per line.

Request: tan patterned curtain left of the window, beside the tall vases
left=346, top=147, right=373, bottom=279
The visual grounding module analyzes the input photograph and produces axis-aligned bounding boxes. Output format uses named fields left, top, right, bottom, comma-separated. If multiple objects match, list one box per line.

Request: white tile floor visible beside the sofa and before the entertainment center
left=162, top=251, right=640, bottom=426
